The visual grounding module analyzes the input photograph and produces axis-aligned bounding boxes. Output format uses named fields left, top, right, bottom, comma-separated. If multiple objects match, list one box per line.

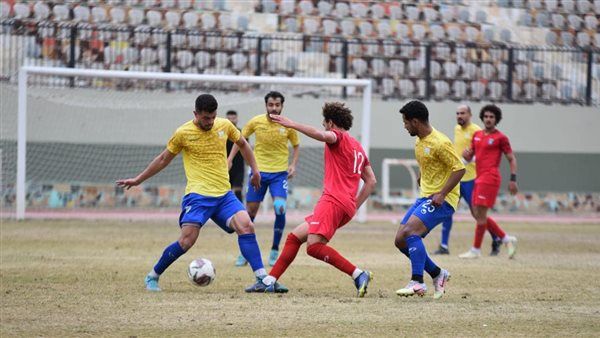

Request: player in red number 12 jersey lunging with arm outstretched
left=246, top=102, right=377, bottom=297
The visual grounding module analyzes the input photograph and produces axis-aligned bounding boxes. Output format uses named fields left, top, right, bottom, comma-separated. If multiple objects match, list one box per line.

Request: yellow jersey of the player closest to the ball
left=167, top=117, right=241, bottom=197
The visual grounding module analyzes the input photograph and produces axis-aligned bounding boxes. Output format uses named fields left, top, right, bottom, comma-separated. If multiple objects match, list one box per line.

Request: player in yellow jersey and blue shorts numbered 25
left=395, top=101, right=465, bottom=299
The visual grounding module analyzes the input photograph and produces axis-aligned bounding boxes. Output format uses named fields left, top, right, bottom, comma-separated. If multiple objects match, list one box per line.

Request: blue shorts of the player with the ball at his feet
left=179, top=191, right=246, bottom=234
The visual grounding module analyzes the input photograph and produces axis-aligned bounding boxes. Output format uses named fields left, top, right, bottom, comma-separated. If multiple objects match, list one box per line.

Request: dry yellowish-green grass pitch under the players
left=0, top=220, right=600, bottom=337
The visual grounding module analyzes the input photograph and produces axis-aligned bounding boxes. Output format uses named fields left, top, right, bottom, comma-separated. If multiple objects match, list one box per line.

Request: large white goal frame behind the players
left=16, top=66, right=373, bottom=222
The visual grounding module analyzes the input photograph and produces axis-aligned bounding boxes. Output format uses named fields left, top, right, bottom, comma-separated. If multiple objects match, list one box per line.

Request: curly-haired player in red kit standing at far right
left=459, top=104, right=519, bottom=258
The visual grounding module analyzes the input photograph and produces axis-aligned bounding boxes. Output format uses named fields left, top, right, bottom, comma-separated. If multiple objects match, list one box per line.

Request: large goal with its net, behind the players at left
left=0, top=66, right=371, bottom=221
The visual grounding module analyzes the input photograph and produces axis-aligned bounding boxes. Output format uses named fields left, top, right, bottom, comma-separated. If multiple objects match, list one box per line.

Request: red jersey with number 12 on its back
left=321, top=129, right=371, bottom=216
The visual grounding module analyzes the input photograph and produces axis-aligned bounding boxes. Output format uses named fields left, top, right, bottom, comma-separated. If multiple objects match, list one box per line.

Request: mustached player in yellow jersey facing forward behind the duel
left=229, top=91, right=300, bottom=266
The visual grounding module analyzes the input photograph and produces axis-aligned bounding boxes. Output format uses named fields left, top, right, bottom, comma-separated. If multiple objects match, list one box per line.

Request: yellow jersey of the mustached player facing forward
left=242, top=114, right=300, bottom=173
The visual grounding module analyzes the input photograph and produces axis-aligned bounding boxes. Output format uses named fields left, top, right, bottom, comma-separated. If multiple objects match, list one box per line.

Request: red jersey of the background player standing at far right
left=471, top=130, right=512, bottom=186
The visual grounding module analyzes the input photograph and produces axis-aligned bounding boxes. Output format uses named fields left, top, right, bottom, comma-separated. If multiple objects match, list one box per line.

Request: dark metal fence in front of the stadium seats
left=0, top=20, right=600, bottom=105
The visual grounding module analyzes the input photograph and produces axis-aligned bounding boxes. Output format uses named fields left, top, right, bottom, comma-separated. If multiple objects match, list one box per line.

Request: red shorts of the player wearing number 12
left=304, top=199, right=354, bottom=241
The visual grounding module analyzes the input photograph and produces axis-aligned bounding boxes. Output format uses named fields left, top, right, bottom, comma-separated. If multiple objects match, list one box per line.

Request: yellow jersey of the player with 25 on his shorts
left=415, top=129, right=465, bottom=210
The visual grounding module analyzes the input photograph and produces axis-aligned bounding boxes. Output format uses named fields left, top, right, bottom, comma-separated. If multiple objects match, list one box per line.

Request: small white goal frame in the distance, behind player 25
left=381, top=158, right=419, bottom=205
